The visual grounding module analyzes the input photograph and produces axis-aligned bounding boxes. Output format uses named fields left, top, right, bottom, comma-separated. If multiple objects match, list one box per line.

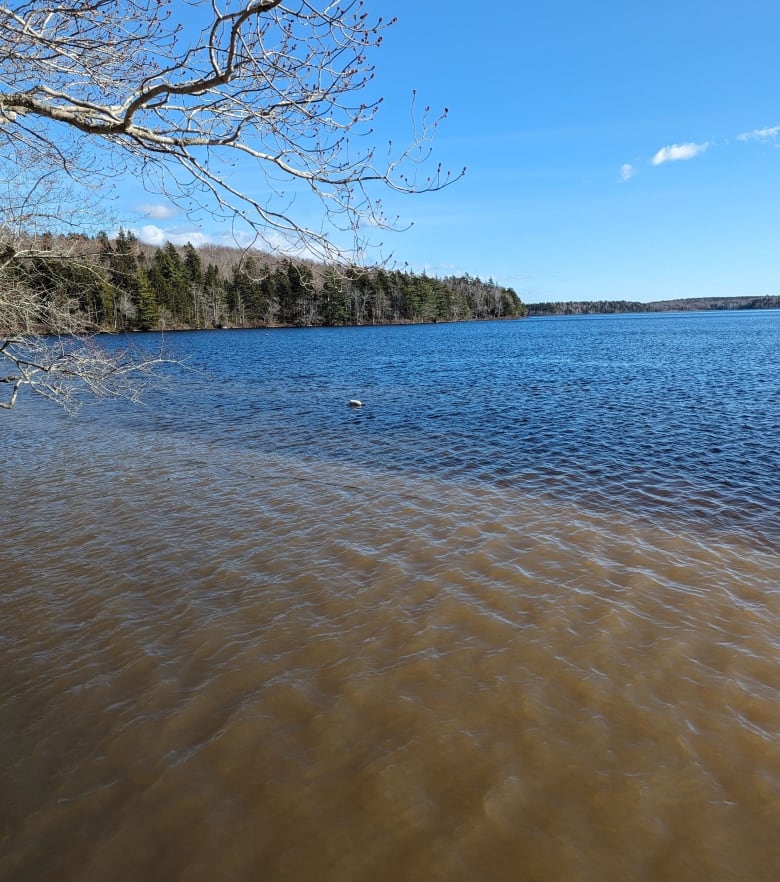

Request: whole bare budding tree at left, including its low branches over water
left=0, top=0, right=459, bottom=404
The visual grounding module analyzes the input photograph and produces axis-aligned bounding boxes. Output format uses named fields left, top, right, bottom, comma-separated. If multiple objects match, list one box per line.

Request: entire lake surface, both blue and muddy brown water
left=0, top=311, right=780, bottom=882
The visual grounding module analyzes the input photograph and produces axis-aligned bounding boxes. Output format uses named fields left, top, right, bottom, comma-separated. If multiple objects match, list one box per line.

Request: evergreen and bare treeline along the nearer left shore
left=10, top=231, right=525, bottom=331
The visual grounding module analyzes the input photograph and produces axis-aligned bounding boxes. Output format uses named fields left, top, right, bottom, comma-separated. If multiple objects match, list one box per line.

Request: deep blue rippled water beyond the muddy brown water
left=102, top=310, right=780, bottom=546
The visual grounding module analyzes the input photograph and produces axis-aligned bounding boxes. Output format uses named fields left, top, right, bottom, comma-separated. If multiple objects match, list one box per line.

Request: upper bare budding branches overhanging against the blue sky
left=0, top=0, right=460, bottom=258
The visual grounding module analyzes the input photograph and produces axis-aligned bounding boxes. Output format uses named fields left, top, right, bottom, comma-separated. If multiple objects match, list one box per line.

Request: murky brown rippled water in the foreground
left=0, top=312, right=780, bottom=882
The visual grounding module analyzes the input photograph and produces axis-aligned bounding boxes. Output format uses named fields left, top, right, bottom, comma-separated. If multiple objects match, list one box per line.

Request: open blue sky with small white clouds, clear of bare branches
left=128, top=0, right=780, bottom=302
